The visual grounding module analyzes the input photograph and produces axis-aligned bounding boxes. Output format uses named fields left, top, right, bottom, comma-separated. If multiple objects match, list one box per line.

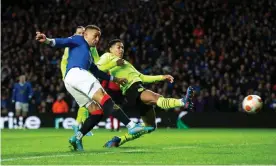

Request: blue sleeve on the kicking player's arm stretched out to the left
left=50, top=36, right=81, bottom=48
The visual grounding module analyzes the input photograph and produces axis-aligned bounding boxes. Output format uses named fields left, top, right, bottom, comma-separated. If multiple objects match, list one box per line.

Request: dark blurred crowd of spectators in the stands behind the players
left=1, top=0, right=276, bottom=113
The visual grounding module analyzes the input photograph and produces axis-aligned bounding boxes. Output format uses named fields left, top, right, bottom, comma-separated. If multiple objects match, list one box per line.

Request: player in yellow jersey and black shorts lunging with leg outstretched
left=96, top=39, right=193, bottom=147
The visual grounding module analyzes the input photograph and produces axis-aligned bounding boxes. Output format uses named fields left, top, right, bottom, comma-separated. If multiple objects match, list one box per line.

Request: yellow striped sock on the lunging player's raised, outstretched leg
left=157, top=97, right=183, bottom=109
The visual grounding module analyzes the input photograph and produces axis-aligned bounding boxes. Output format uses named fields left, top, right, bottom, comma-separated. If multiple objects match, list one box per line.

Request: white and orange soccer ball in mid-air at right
left=242, top=95, right=263, bottom=113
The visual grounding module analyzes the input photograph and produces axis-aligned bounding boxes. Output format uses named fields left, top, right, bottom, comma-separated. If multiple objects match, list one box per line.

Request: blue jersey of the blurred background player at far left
left=12, top=82, right=33, bottom=103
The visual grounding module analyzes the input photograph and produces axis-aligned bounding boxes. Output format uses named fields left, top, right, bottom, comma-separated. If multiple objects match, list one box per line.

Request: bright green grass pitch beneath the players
left=1, top=129, right=276, bottom=165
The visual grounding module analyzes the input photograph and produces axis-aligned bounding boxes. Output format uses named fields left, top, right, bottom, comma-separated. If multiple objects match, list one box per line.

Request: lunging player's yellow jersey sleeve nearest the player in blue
left=97, top=53, right=117, bottom=72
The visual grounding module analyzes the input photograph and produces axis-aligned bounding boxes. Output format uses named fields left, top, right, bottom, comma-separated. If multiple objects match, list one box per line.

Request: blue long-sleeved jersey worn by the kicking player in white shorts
left=51, top=35, right=111, bottom=80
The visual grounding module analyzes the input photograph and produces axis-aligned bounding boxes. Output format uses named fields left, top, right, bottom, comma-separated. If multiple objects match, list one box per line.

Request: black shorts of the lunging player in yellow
left=123, top=82, right=152, bottom=116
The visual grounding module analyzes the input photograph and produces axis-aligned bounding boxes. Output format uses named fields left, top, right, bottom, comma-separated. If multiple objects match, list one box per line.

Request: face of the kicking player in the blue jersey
left=84, top=29, right=101, bottom=47
